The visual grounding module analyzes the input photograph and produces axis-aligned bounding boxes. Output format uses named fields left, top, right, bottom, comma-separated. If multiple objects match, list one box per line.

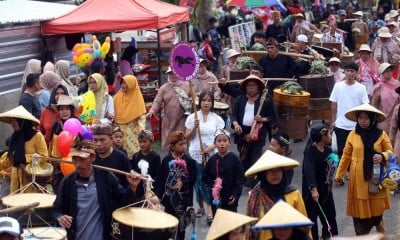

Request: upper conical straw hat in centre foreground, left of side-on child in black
left=245, top=150, right=299, bottom=177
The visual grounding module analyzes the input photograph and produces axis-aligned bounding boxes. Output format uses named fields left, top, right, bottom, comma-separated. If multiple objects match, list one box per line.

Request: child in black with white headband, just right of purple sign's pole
left=203, top=129, right=244, bottom=224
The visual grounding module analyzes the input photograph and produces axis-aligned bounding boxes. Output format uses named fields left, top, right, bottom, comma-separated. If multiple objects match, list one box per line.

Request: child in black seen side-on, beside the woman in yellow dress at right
left=302, top=124, right=338, bottom=240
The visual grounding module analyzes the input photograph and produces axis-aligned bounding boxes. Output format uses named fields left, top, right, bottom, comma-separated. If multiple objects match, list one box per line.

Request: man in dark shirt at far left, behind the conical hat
left=19, top=73, right=42, bottom=119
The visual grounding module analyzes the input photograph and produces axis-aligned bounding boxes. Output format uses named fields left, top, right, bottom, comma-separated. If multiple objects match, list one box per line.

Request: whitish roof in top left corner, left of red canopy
left=0, top=0, right=77, bottom=24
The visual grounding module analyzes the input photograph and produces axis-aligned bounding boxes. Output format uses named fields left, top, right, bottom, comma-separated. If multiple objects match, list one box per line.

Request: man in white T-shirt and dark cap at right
left=329, top=62, right=369, bottom=158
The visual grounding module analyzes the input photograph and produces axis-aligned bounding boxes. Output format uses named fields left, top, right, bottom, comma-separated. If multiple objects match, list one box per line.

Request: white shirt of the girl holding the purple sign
left=185, top=111, right=225, bottom=163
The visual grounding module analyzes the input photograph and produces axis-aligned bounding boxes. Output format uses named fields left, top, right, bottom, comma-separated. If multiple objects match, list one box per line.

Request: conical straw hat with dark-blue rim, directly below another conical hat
left=252, top=200, right=314, bottom=230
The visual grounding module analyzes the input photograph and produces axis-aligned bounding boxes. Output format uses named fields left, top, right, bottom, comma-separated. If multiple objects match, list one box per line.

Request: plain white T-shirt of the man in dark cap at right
left=329, top=80, right=369, bottom=131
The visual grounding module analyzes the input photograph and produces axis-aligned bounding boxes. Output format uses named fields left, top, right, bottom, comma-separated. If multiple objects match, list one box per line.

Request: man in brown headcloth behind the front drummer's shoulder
left=92, top=124, right=130, bottom=187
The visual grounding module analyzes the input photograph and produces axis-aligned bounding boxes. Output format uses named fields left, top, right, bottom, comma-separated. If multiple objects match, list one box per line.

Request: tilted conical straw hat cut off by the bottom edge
left=205, top=208, right=257, bottom=240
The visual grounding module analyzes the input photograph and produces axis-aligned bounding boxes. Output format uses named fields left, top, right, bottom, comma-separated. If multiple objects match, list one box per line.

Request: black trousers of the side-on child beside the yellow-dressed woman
left=303, top=192, right=338, bottom=240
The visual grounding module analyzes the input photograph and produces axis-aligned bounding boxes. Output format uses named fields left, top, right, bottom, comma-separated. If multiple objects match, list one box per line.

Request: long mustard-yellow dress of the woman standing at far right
left=336, top=130, right=393, bottom=219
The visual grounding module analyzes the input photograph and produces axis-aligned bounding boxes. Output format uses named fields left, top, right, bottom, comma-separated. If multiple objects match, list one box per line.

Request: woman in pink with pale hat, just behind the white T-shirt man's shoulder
left=355, top=44, right=379, bottom=96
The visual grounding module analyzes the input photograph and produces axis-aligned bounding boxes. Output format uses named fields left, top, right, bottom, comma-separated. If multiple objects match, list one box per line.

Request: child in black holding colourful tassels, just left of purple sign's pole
left=155, top=131, right=197, bottom=240
